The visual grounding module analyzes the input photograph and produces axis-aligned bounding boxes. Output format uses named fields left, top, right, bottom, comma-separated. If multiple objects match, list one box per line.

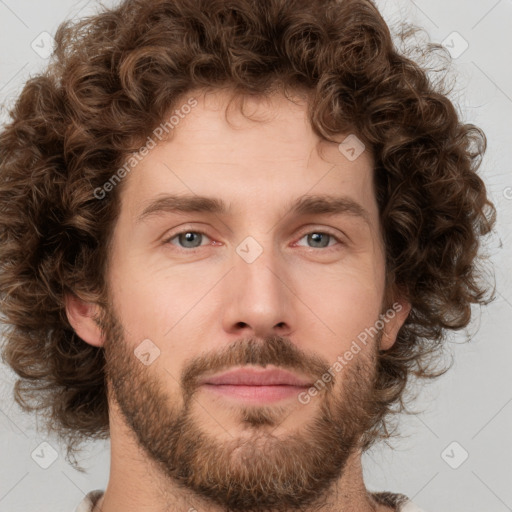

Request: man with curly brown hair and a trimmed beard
left=0, top=0, right=494, bottom=512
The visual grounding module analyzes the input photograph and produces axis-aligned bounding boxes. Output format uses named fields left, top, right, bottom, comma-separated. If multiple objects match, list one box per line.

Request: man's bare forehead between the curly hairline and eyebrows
left=119, top=91, right=376, bottom=221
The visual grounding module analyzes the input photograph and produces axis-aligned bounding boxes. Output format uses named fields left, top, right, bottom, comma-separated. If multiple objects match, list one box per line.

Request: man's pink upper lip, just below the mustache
left=201, top=367, right=313, bottom=388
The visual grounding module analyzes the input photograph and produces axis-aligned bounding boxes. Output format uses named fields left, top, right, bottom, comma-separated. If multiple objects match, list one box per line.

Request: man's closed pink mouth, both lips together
left=201, top=367, right=313, bottom=403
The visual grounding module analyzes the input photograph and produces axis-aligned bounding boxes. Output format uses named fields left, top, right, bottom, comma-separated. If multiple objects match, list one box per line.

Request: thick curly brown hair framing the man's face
left=0, top=0, right=496, bottom=466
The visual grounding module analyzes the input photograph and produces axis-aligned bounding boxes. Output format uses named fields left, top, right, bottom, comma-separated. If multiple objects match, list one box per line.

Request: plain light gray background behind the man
left=0, top=0, right=512, bottom=512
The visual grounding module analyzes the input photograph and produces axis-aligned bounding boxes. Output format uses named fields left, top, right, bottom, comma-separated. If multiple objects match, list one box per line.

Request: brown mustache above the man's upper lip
left=181, top=335, right=333, bottom=395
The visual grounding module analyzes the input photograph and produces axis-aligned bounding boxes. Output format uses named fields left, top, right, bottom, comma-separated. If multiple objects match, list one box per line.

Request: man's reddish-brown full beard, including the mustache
left=102, top=310, right=382, bottom=512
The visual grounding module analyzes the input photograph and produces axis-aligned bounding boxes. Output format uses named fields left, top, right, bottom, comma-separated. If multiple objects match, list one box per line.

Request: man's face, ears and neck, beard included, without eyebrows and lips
left=67, top=91, right=410, bottom=512
